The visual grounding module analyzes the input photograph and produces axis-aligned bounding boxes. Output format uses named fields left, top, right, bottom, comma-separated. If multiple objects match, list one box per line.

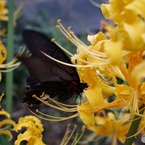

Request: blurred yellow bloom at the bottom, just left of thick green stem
left=88, top=112, right=130, bottom=142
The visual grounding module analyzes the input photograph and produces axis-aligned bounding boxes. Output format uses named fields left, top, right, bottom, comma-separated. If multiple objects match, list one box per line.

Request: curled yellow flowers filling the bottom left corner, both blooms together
left=0, top=93, right=45, bottom=145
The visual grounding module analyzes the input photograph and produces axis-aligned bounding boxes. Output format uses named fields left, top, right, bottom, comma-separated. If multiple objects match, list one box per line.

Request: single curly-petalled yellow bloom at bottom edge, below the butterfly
left=14, top=115, right=45, bottom=145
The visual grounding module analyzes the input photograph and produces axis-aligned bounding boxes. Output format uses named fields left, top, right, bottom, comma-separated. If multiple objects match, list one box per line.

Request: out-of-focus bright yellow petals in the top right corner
left=101, top=0, right=145, bottom=51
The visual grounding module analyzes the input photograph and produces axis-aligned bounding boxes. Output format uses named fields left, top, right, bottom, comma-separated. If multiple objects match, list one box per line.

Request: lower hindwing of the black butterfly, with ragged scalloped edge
left=19, top=55, right=76, bottom=104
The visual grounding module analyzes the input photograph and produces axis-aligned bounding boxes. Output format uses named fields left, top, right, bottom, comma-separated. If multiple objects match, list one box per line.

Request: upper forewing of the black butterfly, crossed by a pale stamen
left=23, top=30, right=80, bottom=81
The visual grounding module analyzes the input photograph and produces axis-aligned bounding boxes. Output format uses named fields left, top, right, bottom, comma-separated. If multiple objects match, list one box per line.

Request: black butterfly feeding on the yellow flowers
left=18, top=30, right=87, bottom=104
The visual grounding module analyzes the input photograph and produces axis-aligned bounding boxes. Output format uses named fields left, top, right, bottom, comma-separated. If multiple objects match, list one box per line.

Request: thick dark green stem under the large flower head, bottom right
left=124, top=105, right=145, bottom=145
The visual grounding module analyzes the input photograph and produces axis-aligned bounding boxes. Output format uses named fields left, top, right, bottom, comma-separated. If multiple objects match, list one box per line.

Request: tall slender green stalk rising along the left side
left=5, top=0, right=14, bottom=145
